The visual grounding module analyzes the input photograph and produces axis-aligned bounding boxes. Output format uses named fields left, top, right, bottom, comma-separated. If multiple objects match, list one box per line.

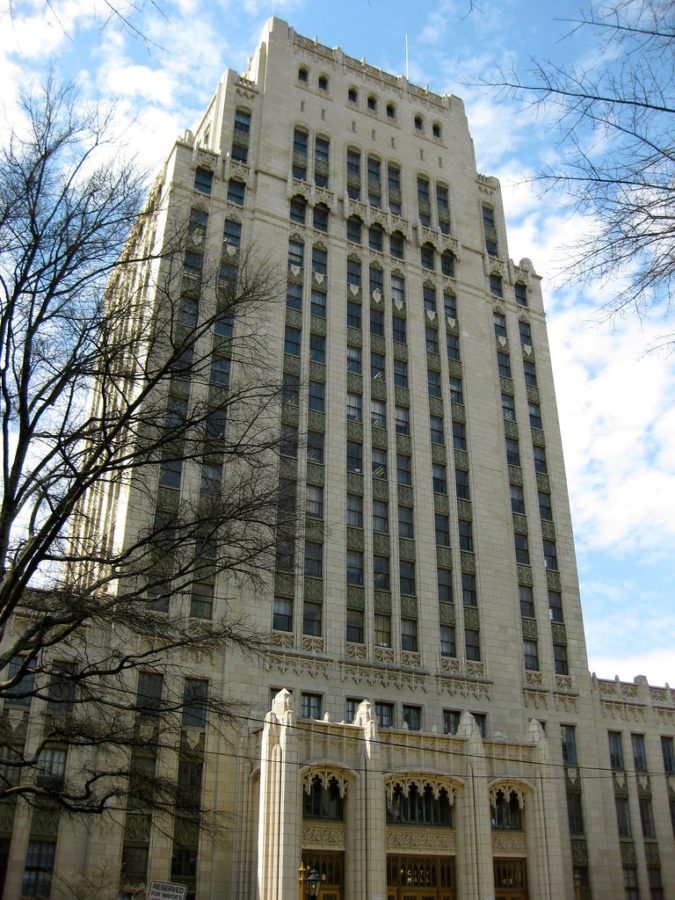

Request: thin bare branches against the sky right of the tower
left=488, top=0, right=675, bottom=324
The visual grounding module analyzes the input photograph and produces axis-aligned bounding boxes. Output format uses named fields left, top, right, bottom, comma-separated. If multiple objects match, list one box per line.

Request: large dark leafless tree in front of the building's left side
left=0, top=84, right=293, bottom=864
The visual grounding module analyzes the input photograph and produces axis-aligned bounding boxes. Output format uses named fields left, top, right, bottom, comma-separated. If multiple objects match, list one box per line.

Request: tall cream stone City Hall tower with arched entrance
left=5, top=19, right=675, bottom=900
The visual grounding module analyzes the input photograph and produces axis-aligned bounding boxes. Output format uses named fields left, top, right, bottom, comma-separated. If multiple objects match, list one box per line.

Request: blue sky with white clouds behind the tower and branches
left=0, top=0, right=675, bottom=686
